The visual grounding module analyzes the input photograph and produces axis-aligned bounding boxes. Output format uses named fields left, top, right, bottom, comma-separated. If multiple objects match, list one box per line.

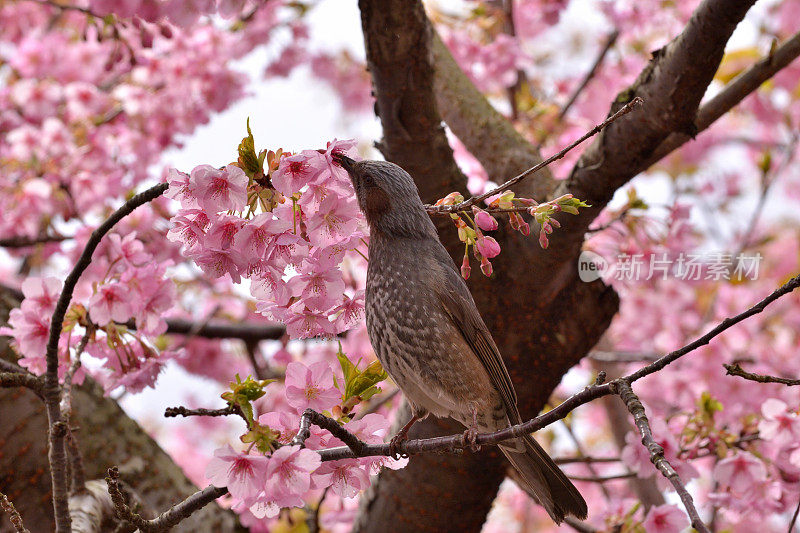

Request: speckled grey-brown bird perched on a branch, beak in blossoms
left=334, top=153, right=588, bottom=523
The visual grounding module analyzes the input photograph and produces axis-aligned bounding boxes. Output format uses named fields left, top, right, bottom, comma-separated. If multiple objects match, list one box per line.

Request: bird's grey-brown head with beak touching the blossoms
left=333, top=153, right=436, bottom=237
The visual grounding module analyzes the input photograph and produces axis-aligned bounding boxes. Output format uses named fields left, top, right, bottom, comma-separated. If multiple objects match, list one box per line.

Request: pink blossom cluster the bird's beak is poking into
left=167, top=141, right=366, bottom=338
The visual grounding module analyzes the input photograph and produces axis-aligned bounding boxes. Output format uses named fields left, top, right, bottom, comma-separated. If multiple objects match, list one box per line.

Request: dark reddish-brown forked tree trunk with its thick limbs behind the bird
left=356, top=0, right=753, bottom=532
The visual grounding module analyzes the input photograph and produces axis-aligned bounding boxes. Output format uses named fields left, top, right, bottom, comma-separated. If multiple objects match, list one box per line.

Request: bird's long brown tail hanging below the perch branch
left=500, top=435, right=588, bottom=524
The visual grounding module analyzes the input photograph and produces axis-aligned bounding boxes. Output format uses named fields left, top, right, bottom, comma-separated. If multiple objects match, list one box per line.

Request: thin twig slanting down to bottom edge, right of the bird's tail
left=617, top=379, right=711, bottom=533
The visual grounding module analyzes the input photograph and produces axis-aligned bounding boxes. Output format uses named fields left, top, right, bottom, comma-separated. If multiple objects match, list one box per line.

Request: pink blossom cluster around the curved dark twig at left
left=3, top=229, right=176, bottom=392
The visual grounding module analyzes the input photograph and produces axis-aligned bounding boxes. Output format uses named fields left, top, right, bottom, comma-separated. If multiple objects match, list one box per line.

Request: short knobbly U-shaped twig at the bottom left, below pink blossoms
left=106, top=466, right=228, bottom=532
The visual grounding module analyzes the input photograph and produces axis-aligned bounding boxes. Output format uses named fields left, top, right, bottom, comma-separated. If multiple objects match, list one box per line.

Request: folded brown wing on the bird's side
left=434, top=268, right=519, bottom=423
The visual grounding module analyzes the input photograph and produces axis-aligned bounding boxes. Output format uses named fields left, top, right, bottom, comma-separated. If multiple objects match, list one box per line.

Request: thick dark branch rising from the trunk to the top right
left=534, top=0, right=754, bottom=301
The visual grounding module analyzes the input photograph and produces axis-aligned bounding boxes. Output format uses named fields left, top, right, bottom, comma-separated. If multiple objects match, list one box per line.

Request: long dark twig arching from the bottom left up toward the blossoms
left=44, top=183, right=168, bottom=533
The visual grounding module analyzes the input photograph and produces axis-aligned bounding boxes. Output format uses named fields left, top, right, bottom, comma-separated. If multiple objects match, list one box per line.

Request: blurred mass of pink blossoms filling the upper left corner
left=0, top=0, right=277, bottom=247
